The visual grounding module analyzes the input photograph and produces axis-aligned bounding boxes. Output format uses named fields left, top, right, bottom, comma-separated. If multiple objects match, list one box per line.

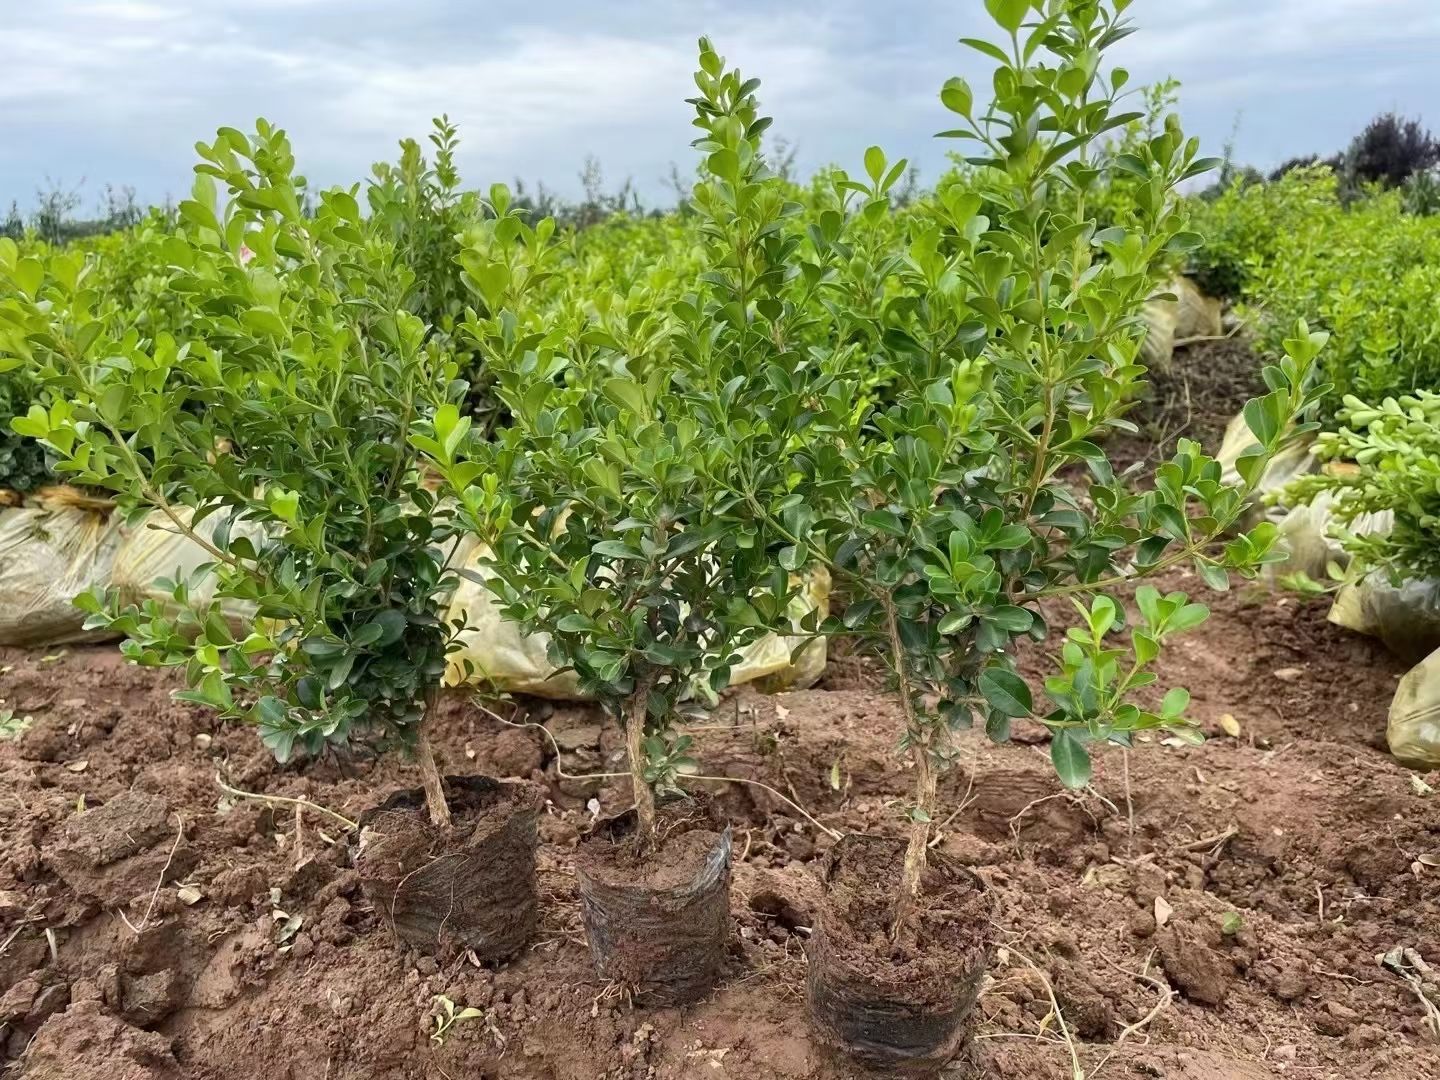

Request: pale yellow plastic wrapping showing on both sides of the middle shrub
left=445, top=544, right=829, bottom=701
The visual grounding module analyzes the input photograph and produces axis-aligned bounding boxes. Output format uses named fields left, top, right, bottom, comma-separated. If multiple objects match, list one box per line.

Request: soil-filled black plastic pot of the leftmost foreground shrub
left=356, top=776, right=544, bottom=963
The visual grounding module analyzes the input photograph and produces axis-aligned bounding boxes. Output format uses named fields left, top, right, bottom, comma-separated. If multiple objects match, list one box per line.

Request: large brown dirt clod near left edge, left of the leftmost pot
left=45, top=791, right=197, bottom=907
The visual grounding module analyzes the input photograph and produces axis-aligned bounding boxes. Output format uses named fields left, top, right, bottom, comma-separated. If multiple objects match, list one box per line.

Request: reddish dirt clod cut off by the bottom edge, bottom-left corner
left=20, top=1002, right=181, bottom=1080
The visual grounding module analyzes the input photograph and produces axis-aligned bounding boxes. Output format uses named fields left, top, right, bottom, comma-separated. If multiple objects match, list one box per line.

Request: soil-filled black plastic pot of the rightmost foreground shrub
left=806, top=834, right=995, bottom=1074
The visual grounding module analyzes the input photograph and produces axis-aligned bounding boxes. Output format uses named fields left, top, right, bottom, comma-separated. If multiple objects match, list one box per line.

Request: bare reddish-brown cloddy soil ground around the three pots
left=0, top=342, right=1440, bottom=1080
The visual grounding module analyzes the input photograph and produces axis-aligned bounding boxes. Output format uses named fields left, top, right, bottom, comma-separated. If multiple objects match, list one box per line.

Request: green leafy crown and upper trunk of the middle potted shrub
left=415, top=43, right=809, bottom=816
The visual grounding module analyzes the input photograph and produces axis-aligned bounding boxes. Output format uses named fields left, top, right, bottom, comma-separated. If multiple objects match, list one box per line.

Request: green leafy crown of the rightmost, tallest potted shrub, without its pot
left=773, top=3, right=1323, bottom=801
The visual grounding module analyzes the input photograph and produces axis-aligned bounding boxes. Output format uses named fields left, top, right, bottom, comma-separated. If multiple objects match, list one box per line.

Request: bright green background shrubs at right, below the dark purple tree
left=1195, top=167, right=1440, bottom=423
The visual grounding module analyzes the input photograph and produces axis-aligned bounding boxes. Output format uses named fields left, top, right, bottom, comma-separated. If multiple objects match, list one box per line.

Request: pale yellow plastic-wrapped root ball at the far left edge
left=0, top=497, right=121, bottom=647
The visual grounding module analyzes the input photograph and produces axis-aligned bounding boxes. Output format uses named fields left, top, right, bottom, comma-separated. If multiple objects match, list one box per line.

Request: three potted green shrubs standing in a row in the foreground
left=0, top=0, right=1325, bottom=1064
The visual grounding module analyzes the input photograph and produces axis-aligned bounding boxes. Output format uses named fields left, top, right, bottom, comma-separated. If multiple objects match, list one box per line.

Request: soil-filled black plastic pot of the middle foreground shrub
left=575, top=796, right=730, bottom=1005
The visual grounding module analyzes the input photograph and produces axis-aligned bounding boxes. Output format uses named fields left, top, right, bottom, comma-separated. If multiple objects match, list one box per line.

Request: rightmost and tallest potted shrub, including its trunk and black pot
left=748, top=0, right=1323, bottom=1070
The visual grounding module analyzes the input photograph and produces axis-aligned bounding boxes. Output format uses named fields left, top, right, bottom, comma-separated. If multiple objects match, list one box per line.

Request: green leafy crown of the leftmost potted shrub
left=0, top=121, right=464, bottom=760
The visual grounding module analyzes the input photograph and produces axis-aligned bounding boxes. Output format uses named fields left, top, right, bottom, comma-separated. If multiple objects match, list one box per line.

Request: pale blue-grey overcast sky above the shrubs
left=0, top=0, right=1440, bottom=207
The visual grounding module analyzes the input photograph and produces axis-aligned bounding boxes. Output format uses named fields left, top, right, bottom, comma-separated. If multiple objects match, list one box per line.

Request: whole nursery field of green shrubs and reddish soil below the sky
left=0, top=0, right=1440, bottom=1080
